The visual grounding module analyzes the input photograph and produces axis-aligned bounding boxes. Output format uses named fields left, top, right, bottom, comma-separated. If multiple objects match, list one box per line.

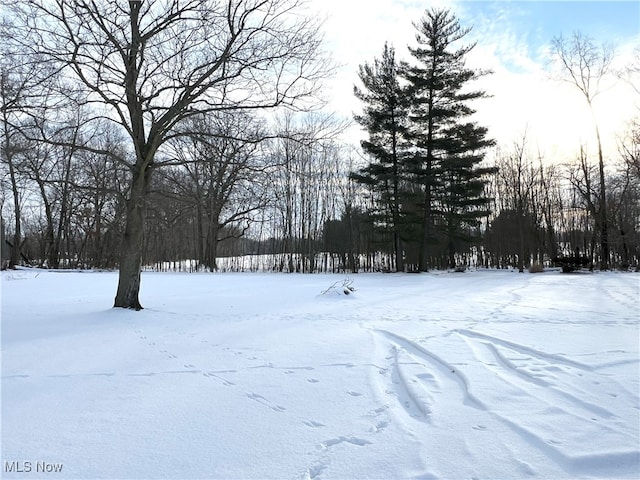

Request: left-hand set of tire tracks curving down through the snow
left=370, top=329, right=517, bottom=479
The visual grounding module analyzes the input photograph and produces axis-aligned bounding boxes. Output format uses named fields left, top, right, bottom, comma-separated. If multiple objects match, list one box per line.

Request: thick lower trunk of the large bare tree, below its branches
left=113, top=168, right=151, bottom=310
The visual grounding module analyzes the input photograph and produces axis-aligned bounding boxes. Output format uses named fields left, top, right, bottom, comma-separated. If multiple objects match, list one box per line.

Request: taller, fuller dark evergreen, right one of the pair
left=402, top=8, right=493, bottom=271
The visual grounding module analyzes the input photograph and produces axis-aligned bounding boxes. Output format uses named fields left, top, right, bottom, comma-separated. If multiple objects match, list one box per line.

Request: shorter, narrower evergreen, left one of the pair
left=352, top=44, right=407, bottom=272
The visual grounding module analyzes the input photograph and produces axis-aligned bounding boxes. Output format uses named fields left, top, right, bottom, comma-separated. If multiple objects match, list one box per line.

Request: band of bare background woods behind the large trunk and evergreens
left=2, top=107, right=640, bottom=272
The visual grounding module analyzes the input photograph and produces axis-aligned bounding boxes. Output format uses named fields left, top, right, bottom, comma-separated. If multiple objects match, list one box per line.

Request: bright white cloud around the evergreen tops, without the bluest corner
left=312, top=0, right=640, bottom=162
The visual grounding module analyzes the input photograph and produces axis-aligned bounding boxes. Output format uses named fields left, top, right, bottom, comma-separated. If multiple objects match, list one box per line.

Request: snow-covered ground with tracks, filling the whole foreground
left=1, top=270, right=640, bottom=480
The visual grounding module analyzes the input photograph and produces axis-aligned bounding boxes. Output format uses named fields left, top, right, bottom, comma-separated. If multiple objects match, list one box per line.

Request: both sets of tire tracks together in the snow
left=372, top=330, right=640, bottom=476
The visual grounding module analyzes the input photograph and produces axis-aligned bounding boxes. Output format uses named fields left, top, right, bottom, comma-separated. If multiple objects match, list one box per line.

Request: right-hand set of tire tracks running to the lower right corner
left=454, top=330, right=640, bottom=475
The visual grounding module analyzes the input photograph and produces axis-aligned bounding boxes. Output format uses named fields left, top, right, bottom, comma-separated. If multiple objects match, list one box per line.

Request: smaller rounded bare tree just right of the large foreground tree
left=162, top=112, right=270, bottom=271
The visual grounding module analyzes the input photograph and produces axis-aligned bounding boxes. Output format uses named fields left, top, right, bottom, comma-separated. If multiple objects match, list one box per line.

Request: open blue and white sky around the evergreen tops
left=320, top=0, right=640, bottom=161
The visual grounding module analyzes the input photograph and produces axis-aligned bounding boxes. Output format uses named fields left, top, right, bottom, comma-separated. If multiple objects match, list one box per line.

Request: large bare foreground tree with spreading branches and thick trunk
left=6, top=0, right=330, bottom=309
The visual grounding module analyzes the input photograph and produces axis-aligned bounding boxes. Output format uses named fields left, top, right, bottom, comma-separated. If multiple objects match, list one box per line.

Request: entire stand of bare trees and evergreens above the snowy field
left=0, top=5, right=640, bottom=274
